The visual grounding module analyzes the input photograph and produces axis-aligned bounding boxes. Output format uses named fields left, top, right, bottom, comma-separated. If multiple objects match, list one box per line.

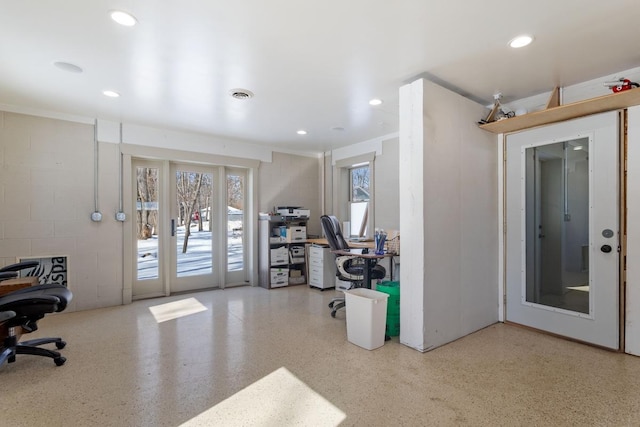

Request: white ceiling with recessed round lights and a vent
left=0, top=0, right=640, bottom=151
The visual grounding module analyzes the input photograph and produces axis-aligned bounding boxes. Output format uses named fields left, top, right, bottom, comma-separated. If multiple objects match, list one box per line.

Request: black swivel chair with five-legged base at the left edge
left=0, top=284, right=73, bottom=366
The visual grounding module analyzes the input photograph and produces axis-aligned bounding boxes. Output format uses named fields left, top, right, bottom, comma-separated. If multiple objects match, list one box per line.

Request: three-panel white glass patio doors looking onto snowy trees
left=132, top=159, right=247, bottom=299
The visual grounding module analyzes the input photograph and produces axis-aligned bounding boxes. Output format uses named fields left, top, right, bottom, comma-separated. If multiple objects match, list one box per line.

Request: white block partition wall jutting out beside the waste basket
left=400, top=81, right=498, bottom=350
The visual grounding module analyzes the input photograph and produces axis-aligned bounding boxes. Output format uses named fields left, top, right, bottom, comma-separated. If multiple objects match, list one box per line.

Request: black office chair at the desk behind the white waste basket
left=320, top=215, right=386, bottom=317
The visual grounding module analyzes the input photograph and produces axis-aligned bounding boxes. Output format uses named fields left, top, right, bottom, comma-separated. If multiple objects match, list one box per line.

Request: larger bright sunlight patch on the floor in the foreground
left=182, top=367, right=346, bottom=427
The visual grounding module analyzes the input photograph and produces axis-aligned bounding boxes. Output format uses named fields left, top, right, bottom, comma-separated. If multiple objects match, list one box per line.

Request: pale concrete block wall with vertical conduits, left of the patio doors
left=0, top=112, right=122, bottom=310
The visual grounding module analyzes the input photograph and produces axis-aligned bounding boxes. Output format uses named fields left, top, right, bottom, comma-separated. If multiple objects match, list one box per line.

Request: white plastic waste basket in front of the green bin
left=344, top=288, right=389, bottom=350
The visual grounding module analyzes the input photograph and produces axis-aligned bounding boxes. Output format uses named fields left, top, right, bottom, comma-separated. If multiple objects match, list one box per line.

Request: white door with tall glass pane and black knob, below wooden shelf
left=506, top=112, right=619, bottom=349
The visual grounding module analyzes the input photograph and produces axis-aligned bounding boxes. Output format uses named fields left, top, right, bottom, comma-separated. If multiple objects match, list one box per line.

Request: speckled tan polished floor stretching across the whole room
left=0, top=286, right=640, bottom=426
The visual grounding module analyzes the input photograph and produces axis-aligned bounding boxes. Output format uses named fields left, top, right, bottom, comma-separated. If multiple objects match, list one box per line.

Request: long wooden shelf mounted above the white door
left=480, top=88, right=640, bottom=133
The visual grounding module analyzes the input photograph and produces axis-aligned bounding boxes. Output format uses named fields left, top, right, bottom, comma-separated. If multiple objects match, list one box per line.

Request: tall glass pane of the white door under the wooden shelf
left=525, top=138, right=589, bottom=313
